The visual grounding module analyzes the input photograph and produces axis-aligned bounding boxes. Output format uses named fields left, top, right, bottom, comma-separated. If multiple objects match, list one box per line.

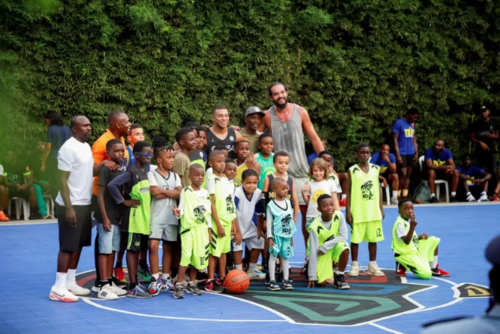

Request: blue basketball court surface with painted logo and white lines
left=0, top=203, right=500, bottom=334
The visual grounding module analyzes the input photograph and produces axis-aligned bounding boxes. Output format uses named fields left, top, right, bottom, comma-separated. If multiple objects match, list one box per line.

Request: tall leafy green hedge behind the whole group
left=0, top=0, right=500, bottom=169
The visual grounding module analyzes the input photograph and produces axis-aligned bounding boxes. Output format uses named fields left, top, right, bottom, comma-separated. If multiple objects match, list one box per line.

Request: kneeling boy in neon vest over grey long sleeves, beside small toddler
left=307, top=194, right=350, bottom=290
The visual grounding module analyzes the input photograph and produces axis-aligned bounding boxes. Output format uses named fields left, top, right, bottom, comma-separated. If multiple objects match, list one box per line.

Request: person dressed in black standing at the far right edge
left=470, top=106, right=498, bottom=192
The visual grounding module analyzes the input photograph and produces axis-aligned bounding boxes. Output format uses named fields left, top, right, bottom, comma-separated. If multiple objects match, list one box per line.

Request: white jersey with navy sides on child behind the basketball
left=234, top=186, right=262, bottom=239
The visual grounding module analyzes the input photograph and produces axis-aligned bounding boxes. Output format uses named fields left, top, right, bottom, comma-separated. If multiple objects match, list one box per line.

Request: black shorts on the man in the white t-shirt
left=57, top=204, right=92, bottom=252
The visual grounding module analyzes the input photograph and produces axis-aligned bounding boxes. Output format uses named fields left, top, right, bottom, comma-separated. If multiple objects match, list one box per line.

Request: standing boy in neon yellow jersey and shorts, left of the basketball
left=173, top=164, right=212, bottom=299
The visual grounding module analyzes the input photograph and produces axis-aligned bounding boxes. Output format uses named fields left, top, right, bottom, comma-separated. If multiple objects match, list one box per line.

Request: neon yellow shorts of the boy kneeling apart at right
left=394, top=237, right=441, bottom=279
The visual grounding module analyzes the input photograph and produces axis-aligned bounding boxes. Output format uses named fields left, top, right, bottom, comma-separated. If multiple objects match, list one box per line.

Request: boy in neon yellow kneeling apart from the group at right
left=392, top=199, right=450, bottom=279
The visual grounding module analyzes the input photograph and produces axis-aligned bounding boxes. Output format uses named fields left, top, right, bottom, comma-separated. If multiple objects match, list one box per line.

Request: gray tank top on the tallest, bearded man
left=270, top=104, right=309, bottom=178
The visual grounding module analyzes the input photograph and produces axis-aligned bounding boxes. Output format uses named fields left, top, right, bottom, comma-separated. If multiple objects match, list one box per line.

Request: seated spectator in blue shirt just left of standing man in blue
left=370, top=144, right=400, bottom=205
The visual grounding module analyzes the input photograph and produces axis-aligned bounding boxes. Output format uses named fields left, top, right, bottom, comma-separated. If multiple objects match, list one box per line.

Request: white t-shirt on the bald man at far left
left=56, top=137, right=94, bottom=206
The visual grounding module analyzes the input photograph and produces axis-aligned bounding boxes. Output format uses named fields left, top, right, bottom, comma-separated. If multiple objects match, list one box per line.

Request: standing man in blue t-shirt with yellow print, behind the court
left=392, top=108, right=420, bottom=197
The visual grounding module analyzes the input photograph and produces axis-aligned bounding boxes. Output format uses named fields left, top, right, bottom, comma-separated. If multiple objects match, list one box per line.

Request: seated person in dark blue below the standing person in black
left=457, top=154, right=491, bottom=202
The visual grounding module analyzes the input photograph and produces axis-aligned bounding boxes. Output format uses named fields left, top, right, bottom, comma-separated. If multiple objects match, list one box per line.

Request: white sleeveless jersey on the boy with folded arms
left=148, top=169, right=181, bottom=226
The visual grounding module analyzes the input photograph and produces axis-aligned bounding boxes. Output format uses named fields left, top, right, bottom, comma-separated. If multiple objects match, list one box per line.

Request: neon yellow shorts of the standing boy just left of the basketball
left=180, top=224, right=210, bottom=270
